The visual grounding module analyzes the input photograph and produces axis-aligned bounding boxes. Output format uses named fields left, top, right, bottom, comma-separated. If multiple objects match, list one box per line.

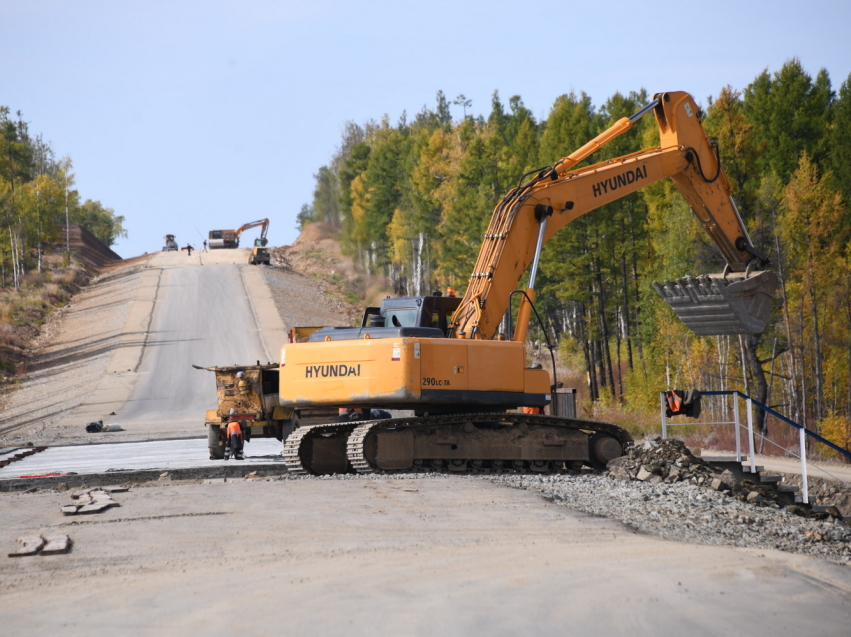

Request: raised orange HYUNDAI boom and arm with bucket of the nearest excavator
left=452, top=92, right=777, bottom=340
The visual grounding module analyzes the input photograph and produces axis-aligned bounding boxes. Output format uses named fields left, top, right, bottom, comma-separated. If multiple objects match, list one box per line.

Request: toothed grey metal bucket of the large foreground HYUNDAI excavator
left=653, top=270, right=777, bottom=336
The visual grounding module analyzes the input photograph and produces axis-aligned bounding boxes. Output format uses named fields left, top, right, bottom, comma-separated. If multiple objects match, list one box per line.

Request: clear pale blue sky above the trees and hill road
left=0, top=0, right=851, bottom=257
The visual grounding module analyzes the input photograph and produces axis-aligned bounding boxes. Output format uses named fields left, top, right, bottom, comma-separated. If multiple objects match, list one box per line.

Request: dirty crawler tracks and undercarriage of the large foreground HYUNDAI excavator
left=284, top=413, right=632, bottom=474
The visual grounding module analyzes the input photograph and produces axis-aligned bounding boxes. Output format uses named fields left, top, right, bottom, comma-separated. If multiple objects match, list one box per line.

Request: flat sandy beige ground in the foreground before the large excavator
left=5, top=478, right=851, bottom=637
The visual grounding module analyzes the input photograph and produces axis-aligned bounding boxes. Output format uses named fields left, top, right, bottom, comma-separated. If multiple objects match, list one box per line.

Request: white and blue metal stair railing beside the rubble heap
left=659, top=391, right=851, bottom=504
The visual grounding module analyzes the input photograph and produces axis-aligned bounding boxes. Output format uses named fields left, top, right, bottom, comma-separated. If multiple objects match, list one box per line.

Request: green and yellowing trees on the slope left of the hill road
left=0, top=106, right=127, bottom=288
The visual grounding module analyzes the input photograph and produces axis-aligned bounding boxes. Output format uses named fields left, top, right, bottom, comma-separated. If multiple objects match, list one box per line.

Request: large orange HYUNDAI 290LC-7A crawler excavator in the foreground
left=279, top=92, right=777, bottom=473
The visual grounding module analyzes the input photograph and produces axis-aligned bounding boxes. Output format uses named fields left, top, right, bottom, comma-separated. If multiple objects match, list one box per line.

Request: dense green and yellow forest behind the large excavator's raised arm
left=298, top=58, right=851, bottom=448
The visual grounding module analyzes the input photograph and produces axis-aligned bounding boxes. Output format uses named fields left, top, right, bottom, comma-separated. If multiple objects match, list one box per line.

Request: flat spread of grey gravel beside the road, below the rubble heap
left=491, top=475, right=851, bottom=566
